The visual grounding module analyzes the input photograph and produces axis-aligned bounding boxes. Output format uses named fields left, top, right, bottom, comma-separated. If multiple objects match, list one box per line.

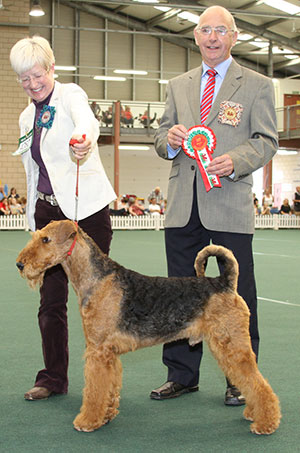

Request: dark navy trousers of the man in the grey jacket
left=163, top=189, right=259, bottom=386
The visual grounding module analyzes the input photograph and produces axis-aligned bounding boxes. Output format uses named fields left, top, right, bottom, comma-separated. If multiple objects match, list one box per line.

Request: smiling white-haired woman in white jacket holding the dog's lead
left=10, top=36, right=115, bottom=400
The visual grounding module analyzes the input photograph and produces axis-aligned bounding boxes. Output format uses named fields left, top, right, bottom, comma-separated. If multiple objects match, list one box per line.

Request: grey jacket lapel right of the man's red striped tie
left=206, top=60, right=242, bottom=125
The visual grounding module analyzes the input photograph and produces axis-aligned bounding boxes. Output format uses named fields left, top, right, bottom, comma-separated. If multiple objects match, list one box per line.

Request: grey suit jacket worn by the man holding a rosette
left=155, top=60, right=278, bottom=234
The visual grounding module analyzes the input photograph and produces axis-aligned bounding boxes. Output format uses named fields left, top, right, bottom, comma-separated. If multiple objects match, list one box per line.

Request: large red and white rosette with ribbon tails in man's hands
left=182, top=125, right=222, bottom=192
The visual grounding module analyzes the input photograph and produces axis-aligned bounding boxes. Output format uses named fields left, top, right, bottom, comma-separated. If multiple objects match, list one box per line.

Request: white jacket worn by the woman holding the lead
left=19, top=82, right=116, bottom=231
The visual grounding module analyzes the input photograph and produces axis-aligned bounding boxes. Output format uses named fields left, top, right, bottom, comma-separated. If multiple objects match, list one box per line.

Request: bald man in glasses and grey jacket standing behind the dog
left=150, top=6, right=278, bottom=406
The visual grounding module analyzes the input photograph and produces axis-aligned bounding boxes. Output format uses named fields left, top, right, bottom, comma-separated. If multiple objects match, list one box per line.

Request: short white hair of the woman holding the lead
left=10, top=36, right=55, bottom=75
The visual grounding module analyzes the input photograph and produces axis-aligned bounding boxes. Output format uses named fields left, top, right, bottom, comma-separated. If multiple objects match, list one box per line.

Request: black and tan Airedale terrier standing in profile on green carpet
left=17, top=220, right=280, bottom=434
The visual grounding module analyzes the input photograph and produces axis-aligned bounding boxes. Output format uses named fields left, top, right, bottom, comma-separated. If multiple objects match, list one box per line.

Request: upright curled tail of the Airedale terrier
left=194, top=245, right=239, bottom=291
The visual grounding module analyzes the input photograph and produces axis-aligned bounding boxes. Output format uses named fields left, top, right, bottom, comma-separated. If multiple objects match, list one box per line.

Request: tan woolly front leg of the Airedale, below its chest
left=73, top=345, right=120, bottom=432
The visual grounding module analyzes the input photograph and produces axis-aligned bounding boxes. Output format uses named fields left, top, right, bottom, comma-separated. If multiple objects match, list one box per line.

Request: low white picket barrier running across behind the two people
left=0, top=214, right=300, bottom=231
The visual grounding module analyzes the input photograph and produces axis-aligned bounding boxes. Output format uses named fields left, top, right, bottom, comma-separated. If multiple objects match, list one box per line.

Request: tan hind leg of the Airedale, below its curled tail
left=202, top=295, right=281, bottom=434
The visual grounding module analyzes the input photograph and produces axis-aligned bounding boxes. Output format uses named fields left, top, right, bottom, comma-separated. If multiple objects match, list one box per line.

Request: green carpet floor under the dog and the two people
left=0, top=230, right=300, bottom=453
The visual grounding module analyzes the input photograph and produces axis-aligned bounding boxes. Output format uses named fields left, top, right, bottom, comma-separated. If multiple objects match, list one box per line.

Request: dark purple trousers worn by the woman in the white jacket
left=35, top=200, right=112, bottom=393
